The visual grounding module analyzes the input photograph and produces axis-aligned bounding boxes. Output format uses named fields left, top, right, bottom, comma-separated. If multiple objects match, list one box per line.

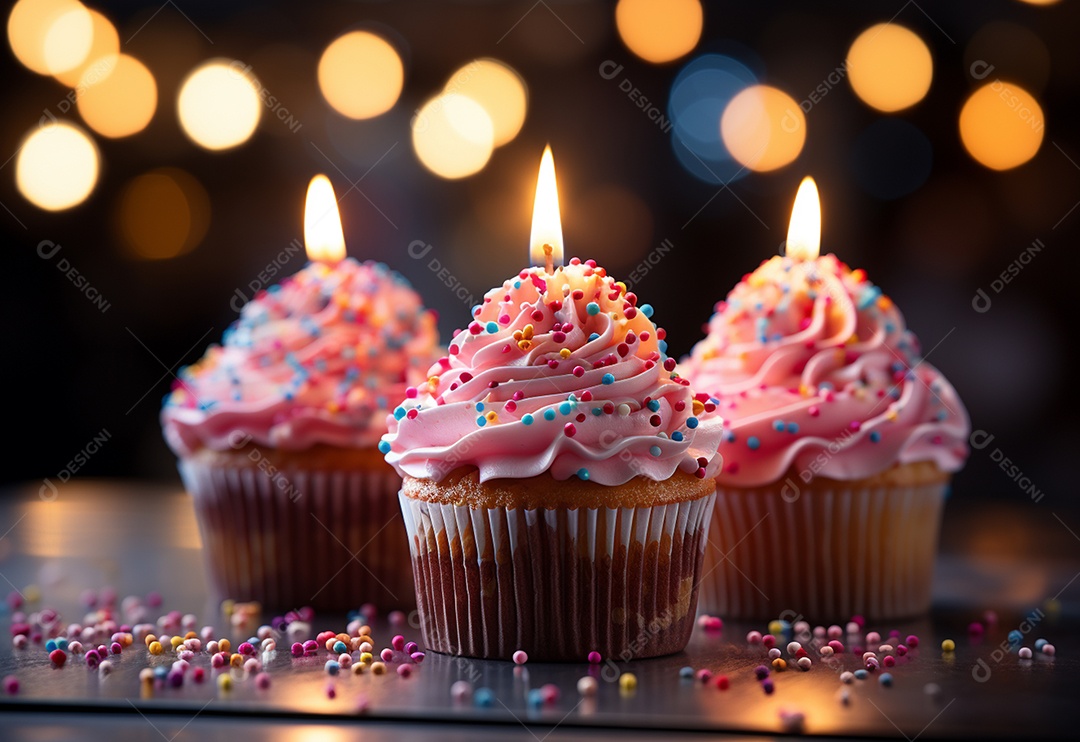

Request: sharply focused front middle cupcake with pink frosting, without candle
left=381, top=258, right=721, bottom=661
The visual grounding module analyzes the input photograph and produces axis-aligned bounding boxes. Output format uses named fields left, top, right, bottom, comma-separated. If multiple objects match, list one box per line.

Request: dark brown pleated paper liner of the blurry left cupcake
left=179, top=460, right=416, bottom=610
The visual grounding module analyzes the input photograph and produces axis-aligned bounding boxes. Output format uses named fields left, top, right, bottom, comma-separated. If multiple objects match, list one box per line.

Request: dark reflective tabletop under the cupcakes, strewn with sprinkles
left=0, top=481, right=1080, bottom=741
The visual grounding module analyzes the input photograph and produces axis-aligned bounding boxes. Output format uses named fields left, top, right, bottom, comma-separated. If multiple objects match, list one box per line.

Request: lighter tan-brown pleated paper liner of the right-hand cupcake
left=701, top=484, right=946, bottom=622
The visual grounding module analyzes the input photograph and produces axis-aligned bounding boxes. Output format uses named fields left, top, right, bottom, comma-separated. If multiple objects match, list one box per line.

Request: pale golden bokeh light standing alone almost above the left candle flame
left=319, top=31, right=405, bottom=119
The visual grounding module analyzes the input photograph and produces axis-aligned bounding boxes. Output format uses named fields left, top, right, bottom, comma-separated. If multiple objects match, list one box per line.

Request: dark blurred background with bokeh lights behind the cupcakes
left=0, top=0, right=1080, bottom=516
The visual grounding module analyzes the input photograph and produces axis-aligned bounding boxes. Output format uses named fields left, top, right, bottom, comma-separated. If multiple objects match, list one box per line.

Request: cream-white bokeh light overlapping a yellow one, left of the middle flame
left=413, top=93, right=495, bottom=179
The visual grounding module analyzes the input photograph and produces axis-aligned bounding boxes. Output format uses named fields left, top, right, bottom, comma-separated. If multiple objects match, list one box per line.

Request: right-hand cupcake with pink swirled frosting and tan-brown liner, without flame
left=679, top=255, right=970, bottom=620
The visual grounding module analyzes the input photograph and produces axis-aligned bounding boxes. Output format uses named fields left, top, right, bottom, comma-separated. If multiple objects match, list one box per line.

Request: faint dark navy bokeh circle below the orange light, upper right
left=852, top=119, right=934, bottom=201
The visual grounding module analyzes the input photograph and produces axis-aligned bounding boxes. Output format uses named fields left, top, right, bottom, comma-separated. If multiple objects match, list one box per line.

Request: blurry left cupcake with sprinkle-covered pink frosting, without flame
left=161, top=258, right=438, bottom=609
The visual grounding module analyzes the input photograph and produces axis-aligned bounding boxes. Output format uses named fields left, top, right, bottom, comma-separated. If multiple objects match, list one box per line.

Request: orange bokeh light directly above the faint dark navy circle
left=847, top=23, right=934, bottom=113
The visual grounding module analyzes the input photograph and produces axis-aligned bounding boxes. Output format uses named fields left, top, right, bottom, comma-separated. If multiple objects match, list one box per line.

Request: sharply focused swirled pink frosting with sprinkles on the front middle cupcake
left=380, top=258, right=721, bottom=485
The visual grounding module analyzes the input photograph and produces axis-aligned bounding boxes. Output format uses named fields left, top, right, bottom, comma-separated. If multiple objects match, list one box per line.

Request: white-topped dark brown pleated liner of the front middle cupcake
left=401, top=493, right=714, bottom=661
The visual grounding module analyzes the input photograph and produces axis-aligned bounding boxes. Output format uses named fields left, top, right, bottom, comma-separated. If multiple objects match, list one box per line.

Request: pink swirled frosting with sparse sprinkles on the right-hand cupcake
left=679, top=255, right=970, bottom=487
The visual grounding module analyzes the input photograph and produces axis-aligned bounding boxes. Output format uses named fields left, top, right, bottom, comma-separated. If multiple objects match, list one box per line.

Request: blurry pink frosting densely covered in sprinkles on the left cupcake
left=161, top=258, right=438, bottom=456
